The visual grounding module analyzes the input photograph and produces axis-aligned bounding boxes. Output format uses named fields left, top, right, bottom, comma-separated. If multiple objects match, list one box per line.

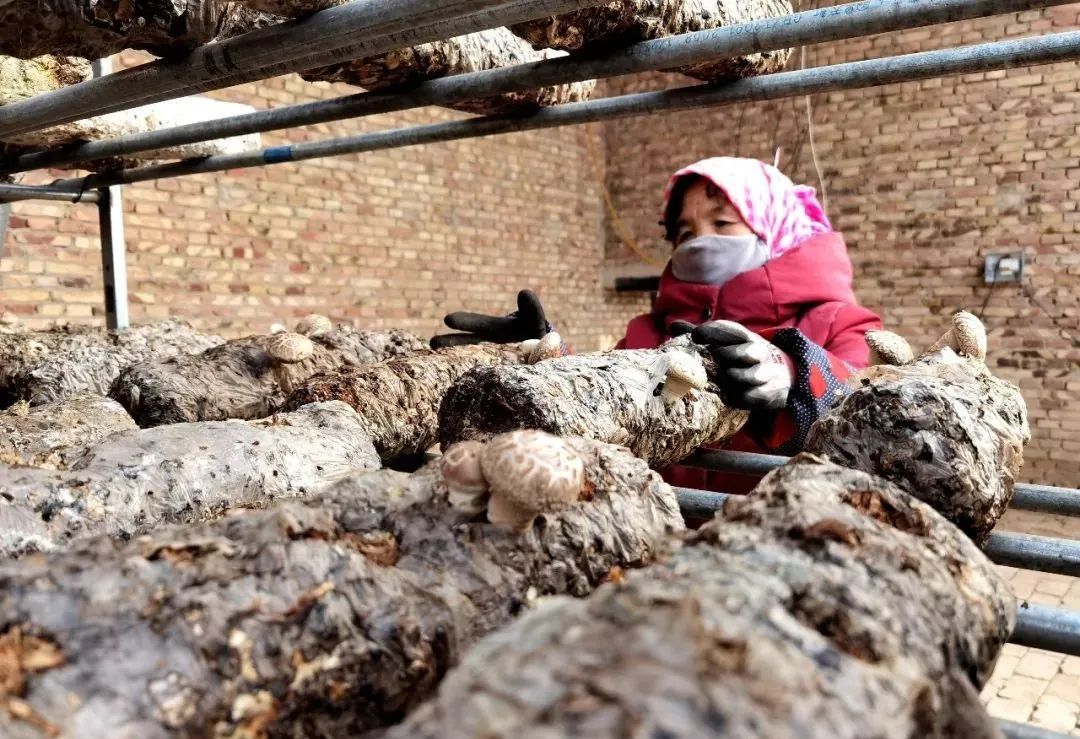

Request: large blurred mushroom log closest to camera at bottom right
left=384, top=457, right=1016, bottom=739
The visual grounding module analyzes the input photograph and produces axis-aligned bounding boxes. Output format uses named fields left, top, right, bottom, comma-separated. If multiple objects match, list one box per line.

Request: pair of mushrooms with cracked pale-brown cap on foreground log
left=441, top=430, right=585, bottom=533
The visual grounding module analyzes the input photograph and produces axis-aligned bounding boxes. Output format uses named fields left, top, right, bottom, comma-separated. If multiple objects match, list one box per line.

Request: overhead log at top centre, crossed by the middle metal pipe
left=302, top=28, right=596, bottom=116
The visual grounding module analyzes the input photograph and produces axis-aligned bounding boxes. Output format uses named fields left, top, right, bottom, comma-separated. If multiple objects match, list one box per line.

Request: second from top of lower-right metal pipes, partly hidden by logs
left=675, top=487, right=1080, bottom=577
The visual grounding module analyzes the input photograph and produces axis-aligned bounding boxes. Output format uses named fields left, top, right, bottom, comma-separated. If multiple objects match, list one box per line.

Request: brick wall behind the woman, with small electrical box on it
left=607, top=5, right=1080, bottom=490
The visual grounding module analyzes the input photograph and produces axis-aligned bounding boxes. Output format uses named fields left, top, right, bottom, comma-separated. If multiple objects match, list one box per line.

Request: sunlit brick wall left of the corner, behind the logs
left=0, top=51, right=625, bottom=350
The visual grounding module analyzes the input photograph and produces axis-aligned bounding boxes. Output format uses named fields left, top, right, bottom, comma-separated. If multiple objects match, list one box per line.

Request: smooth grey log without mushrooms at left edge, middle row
left=0, top=403, right=380, bottom=556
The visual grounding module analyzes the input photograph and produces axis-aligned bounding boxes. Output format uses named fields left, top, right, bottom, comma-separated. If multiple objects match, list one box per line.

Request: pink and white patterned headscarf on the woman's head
left=661, top=157, right=833, bottom=258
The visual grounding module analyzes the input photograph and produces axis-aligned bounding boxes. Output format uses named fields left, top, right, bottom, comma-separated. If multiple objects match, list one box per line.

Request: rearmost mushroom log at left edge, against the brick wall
left=0, top=321, right=224, bottom=408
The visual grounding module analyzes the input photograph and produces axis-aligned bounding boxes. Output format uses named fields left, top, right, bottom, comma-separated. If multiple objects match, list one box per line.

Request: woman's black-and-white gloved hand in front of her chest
left=672, top=321, right=794, bottom=411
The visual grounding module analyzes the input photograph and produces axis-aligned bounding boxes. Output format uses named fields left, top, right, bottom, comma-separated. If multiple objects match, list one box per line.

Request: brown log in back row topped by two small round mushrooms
left=110, top=324, right=424, bottom=428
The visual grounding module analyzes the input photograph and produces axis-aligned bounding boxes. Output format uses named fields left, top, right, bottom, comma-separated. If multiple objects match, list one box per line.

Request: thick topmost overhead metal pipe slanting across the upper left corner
left=0, top=0, right=602, bottom=138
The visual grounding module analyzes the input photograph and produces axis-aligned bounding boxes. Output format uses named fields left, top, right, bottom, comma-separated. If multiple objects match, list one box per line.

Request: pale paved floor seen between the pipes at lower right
left=983, top=512, right=1080, bottom=737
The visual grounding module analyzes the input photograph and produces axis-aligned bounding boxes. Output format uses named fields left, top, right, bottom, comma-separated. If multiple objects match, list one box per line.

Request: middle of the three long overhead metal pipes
left=0, top=0, right=1067, bottom=173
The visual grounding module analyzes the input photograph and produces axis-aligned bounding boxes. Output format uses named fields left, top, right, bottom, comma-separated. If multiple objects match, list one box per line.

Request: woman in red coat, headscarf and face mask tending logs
left=432, top=157, right=881, bottom=493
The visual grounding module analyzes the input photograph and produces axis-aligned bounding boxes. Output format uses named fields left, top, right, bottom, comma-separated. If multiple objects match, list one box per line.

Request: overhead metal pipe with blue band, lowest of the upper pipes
left=48, top=31, right=1080, bottom=189
